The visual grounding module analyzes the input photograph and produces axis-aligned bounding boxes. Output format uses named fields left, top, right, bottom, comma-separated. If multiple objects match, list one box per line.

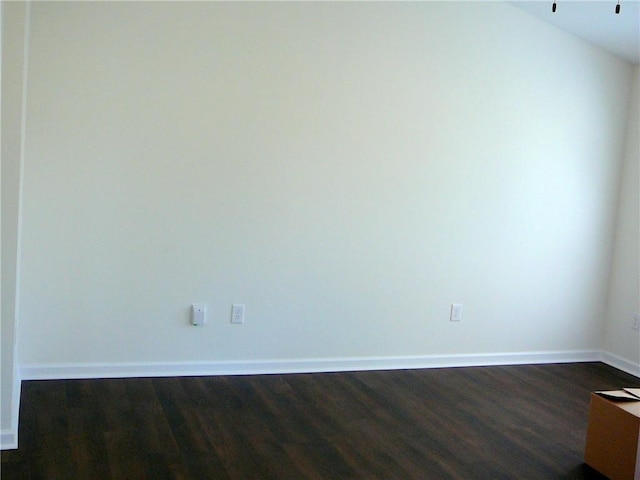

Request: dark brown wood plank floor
left=2, top=363, right=640, bottom=480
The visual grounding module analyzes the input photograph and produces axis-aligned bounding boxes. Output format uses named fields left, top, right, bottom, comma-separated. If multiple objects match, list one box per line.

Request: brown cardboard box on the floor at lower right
left=584, top=393, right=640, bottom=480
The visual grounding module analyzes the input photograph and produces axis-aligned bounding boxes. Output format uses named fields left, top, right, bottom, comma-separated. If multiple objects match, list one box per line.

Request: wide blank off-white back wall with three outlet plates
left=18, top=2, right=632, bottom=369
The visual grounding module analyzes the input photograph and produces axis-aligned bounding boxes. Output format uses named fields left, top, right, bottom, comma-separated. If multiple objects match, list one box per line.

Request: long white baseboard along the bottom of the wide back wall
left=20, top=350, right=602, bottom=380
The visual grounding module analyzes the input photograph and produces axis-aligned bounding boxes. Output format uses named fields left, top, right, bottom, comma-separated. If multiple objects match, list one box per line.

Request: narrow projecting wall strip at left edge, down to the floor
left=0, top=2, right=28, bottom=448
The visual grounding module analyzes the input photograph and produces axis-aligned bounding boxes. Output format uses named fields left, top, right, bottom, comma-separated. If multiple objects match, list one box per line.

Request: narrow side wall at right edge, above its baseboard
left=605, top=66, right=640, bottom=374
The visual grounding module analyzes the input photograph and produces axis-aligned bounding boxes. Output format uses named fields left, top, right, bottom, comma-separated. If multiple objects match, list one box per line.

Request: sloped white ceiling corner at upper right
left=509, top=0, right=640, bottom=65
